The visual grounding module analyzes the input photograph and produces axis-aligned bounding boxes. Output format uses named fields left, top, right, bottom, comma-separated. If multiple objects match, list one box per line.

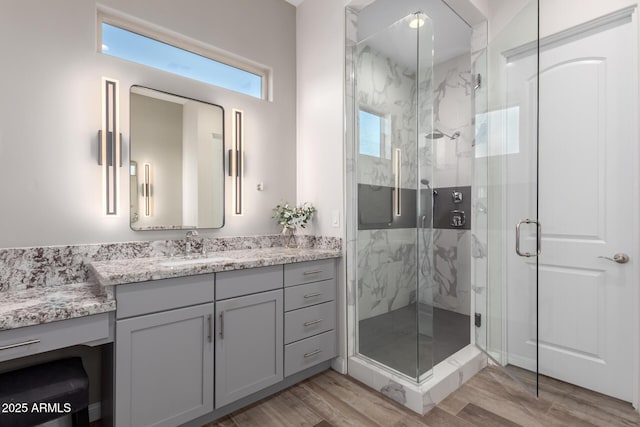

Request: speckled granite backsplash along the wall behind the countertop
left=0, top=234, right=342, bottom=291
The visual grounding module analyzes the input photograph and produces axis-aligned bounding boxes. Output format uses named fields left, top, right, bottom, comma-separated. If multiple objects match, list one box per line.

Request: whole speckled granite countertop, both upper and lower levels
left=0, top=247, right=342, bottom=331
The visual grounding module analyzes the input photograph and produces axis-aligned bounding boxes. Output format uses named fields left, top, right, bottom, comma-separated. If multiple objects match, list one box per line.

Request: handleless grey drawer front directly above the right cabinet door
left=216, top=265, right=282, bottom=301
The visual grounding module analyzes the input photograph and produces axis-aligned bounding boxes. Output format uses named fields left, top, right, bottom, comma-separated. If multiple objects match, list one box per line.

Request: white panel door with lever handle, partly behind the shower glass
left=508, top=10, right=638, bottom=401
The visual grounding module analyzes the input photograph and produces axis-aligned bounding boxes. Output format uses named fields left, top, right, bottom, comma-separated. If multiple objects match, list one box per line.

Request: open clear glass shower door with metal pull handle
left=476, top=0, right=541, bottom=393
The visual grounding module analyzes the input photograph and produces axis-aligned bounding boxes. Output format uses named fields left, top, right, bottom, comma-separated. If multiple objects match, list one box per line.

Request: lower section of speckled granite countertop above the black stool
left=0, top=283, right=116, bottom=331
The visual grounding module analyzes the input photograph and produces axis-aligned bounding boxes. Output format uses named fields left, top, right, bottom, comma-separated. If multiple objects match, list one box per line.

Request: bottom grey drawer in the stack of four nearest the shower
left=284, top=331, right=336, bottom=377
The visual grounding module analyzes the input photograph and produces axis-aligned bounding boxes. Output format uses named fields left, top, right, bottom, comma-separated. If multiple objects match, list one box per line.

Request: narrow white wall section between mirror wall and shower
left=296, top=0, right=348, bottom=237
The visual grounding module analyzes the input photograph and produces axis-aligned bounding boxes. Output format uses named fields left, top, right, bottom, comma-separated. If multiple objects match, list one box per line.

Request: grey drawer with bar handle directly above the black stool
left=0, top=313, right=113, bottom=362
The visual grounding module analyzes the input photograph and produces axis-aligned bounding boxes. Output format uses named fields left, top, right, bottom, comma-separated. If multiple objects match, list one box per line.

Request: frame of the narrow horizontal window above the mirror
left=96, top=7, right=273, bottom=101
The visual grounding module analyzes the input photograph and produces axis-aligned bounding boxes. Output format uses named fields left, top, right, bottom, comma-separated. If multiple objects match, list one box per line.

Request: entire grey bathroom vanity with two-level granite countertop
left=0, top=247, right=341, bottom=427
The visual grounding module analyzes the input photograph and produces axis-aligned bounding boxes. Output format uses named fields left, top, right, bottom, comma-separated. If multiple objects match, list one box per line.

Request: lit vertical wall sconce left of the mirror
left=98, top=77, right=122, bottom=215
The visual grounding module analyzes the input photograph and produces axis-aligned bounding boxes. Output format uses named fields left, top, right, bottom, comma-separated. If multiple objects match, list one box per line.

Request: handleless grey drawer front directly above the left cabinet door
left=116, top=274, right=214, bottom=319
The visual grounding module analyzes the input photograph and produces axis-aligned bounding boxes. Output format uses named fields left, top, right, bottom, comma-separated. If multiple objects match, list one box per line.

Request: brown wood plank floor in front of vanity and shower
left=203, top=367, right=640, bottom=427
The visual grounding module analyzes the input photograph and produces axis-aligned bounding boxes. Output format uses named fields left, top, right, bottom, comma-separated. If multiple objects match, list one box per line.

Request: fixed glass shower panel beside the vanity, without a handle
left=353, top=14, right=433, bottom=381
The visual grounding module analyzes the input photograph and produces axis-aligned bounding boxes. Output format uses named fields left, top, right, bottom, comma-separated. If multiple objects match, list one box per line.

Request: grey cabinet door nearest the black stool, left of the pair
left=115, top=303, right=214, bottom=427
